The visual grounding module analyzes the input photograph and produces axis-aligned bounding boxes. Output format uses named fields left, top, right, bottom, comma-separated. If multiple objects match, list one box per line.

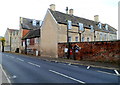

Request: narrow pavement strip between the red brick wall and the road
left=10, top=53, right=120, bottom=70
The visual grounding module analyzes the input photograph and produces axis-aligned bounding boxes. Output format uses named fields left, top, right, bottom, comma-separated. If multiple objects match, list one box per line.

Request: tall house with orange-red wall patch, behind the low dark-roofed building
left=19, top=17, right=42, bottom=53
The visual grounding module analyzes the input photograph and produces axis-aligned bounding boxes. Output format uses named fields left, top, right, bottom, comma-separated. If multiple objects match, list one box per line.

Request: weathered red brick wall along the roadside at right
left=58, top=40, right=120, bottom=62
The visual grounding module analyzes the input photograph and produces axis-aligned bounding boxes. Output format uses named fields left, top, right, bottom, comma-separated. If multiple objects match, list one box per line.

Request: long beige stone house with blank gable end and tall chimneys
left=40, top=4, right=117, bottom=58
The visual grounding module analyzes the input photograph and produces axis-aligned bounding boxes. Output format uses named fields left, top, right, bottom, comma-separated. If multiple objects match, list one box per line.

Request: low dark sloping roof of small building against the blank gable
left=22, top=29, right=40, bottom=40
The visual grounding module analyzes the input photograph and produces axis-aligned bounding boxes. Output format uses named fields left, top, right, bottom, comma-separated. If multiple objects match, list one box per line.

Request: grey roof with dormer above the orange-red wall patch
left=20, top=17, right=40, bottom=30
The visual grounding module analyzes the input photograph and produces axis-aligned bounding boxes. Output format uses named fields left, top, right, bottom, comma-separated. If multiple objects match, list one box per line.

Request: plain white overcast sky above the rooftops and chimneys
left=0, top=0, right=119, bottom=36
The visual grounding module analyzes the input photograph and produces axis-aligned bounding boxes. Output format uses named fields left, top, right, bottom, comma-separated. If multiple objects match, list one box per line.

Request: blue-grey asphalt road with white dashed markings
left=0, top=53, right=120, bottom=85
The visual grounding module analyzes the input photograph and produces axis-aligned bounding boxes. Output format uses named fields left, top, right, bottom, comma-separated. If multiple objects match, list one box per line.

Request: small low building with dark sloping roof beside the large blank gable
left=22, top=29, right=40, bottom=56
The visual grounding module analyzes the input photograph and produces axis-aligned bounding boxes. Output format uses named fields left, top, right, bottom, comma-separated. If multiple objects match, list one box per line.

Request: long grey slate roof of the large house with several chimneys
left=49, top=9, right=117, bottom=34
